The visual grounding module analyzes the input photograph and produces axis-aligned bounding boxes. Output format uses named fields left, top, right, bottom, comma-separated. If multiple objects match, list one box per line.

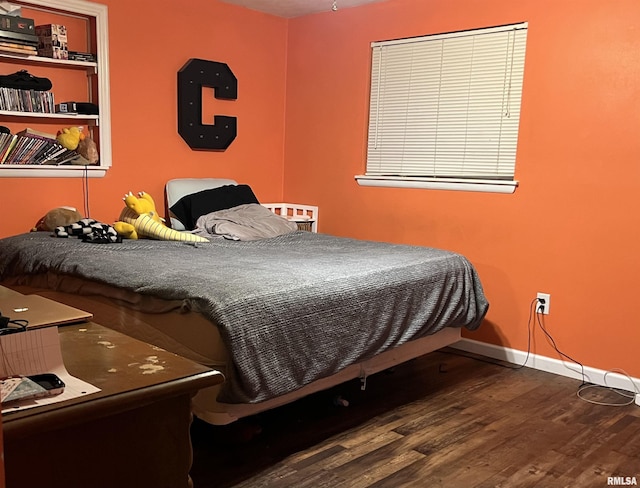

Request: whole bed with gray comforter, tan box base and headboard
left=0, top=178, right=488, bottom=425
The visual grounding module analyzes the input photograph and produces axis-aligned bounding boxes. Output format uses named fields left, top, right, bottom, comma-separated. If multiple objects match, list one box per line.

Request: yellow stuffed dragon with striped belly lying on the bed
left=113, top=192, right=209, bottom=242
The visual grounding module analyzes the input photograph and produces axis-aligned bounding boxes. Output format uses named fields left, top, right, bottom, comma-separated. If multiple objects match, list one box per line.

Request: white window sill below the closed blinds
left=355, top=175, right=518, bottom=193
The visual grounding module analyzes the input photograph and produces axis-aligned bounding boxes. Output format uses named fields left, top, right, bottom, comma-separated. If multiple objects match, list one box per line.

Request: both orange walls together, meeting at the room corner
left=0, top=0, right=640, bottom=377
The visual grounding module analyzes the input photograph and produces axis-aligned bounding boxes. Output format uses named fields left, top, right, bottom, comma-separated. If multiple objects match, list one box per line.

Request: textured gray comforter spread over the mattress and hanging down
left=0, top=231, right=488, bottom=403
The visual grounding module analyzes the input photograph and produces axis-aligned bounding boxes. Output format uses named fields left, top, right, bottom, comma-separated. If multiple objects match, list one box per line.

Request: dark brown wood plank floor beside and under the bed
left=192, top=350, right=640, bottom=488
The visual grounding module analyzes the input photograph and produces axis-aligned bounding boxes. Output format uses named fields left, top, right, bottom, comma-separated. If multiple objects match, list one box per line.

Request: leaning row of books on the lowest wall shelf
left=0, top=128, right=78, bottom=165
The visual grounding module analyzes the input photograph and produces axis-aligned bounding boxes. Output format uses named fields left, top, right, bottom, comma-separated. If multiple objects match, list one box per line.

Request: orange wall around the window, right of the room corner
left=284, top=0, right=640, bottom=377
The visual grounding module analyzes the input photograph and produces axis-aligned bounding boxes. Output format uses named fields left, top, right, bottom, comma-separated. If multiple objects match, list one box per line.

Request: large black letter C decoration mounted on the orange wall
left=178, top=58, right=238, bottom=150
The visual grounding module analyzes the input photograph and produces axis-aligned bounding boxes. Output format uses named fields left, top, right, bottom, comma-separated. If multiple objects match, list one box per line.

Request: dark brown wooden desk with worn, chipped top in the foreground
left=2, top=323, right=223, bottom=488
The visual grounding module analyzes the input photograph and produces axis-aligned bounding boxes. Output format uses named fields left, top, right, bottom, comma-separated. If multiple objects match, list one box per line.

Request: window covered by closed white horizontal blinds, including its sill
left=356, top=23, right=527, bottom=193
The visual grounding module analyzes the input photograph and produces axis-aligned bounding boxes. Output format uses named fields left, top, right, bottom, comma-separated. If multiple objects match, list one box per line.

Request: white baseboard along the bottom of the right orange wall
left=449, top=339, right=640, bottom=398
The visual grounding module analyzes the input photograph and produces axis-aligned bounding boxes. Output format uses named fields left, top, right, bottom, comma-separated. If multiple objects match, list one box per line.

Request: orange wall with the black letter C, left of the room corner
left=0, top=0, right=287, bottom=237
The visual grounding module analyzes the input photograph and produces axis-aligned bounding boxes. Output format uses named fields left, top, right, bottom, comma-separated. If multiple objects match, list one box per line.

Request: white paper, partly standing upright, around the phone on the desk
left=0, top=327, right=100, bottom=413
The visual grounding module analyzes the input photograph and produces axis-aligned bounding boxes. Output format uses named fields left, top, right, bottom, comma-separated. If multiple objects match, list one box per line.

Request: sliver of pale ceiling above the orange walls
left=221, top=0, right=383, bottom=18
